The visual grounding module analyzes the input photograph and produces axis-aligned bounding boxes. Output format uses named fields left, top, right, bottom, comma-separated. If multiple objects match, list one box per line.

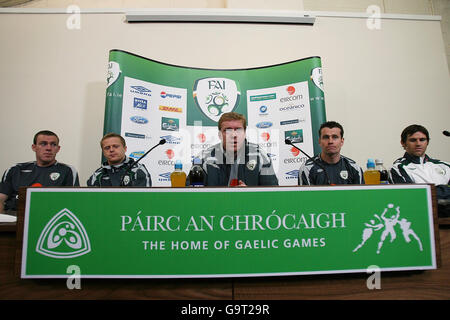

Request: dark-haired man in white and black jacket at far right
left=390, top=124, right=450, bottom=200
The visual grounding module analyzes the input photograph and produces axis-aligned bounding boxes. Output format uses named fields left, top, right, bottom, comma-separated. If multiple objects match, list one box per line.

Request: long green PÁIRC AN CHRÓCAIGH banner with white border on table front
left=21, top=185, right=436, bottom=278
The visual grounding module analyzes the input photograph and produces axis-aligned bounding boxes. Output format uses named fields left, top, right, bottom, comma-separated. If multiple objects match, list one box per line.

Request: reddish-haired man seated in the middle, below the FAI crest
left=196, top=112, right=278, bottom=186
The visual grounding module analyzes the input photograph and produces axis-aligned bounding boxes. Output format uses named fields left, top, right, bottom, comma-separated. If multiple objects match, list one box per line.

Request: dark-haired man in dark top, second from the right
left=298, top=121, right=364, bottom=185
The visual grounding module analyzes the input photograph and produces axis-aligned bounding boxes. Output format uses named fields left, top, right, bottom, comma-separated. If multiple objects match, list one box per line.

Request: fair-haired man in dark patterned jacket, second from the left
left=87, top=133, right=152, bottom=187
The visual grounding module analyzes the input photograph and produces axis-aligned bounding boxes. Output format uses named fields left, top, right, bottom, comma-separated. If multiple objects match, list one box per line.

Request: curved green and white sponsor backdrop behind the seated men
left=104, top=50, right=326, bottom=186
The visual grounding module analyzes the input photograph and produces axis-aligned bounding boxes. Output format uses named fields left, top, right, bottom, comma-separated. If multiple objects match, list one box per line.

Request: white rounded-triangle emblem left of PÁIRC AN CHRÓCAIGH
left=36, top=209, right=91, bottom=259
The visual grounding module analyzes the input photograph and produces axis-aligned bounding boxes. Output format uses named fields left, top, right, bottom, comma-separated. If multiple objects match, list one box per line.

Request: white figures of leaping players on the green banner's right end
left=353, top=204, right=423, bottom=254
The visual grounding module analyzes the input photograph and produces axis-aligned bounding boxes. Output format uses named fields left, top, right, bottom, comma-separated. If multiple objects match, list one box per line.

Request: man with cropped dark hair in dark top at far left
left=0, top=130, right=80, bottom=213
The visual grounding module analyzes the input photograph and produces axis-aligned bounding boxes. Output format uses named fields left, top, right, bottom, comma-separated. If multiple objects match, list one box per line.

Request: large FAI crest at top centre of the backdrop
left=194, top=78, right=241, bottom=122
